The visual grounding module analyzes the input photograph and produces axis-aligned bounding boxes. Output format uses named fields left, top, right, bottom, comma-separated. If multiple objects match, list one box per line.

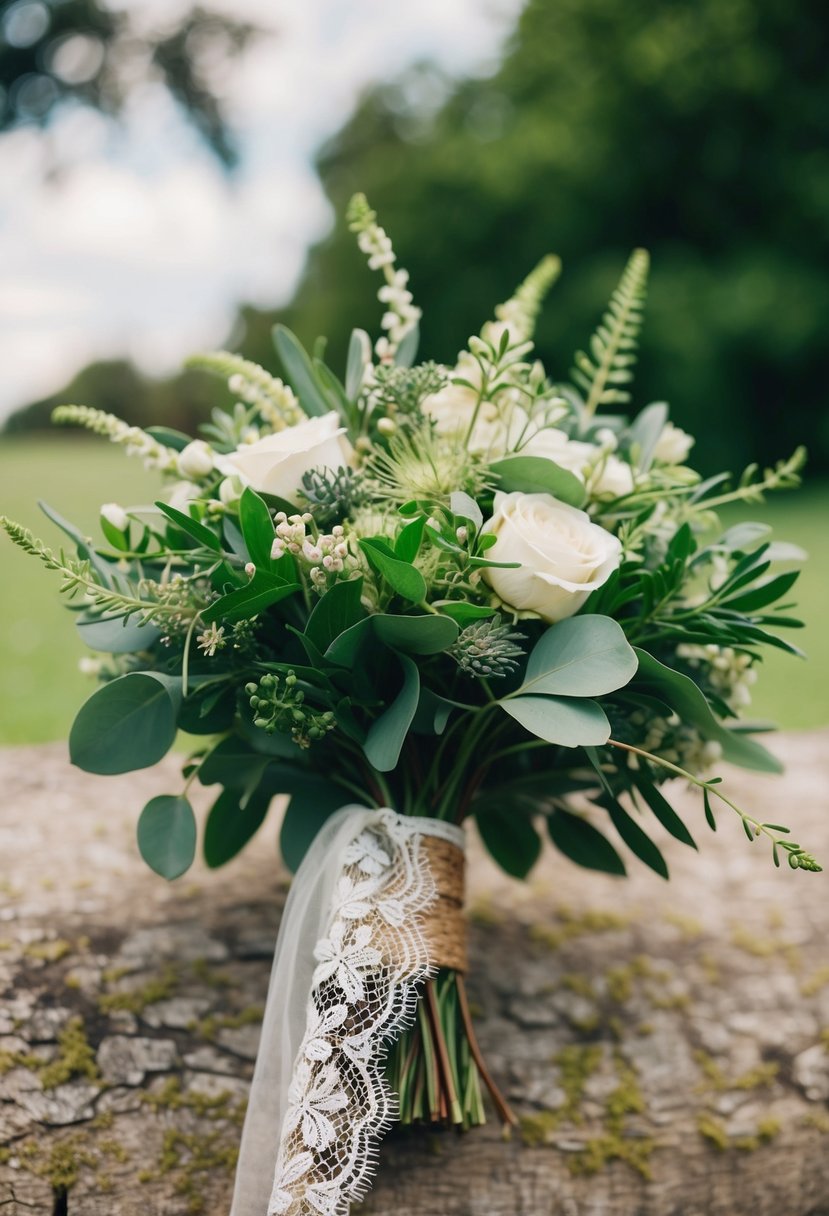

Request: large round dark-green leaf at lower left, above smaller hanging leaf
left=69, top=671, right=181, bottom=775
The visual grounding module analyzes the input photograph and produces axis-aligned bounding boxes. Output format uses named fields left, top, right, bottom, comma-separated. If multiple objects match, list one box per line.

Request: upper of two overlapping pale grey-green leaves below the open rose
left=519, top=615, right=637, bottom=697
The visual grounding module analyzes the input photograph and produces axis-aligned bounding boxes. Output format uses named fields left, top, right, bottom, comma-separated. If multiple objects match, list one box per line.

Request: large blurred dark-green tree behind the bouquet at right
left=235, top=0, right=829, bottom=469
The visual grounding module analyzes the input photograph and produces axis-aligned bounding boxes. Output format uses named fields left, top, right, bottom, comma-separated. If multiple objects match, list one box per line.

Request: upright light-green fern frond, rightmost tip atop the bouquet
left=571, top=249, right=650, bottom=417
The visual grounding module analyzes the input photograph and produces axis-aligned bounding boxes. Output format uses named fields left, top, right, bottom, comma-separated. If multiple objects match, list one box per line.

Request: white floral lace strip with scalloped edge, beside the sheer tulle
left=267, top=810, right=463, bottom=1216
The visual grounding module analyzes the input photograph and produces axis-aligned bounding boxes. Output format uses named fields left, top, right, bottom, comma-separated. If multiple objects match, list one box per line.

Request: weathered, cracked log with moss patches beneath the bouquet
left=0, top=732, right=829, bottom=1216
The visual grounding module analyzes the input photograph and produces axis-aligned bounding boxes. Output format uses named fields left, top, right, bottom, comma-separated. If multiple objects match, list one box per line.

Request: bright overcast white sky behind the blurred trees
left=0, top=0, right=519, bottom=417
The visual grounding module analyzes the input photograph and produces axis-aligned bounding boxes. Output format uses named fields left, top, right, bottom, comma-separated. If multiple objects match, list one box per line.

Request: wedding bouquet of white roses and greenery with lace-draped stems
left=2, top=196, right=820, bottom=1216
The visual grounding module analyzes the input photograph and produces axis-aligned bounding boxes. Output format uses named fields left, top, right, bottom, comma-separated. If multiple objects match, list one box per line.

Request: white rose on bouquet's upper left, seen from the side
left=222, top=410, right=351, bottom=502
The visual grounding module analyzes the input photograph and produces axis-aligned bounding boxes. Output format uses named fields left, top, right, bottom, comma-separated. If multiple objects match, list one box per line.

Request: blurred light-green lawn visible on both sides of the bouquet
left=0, top=437, right=829, bottom=744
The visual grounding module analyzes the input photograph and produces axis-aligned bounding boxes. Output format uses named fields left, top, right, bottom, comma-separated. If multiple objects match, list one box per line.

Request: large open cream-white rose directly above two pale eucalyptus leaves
left=483, top=492, right=621, bottom=623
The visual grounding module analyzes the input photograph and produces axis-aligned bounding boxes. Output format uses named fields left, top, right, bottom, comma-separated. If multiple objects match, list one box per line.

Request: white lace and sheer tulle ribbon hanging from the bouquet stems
left=231, top=806, right=463, bottom=1216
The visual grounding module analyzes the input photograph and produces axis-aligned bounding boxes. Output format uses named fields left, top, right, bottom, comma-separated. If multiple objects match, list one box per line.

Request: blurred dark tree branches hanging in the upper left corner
left=0, top=0, right=256, bottom=165
